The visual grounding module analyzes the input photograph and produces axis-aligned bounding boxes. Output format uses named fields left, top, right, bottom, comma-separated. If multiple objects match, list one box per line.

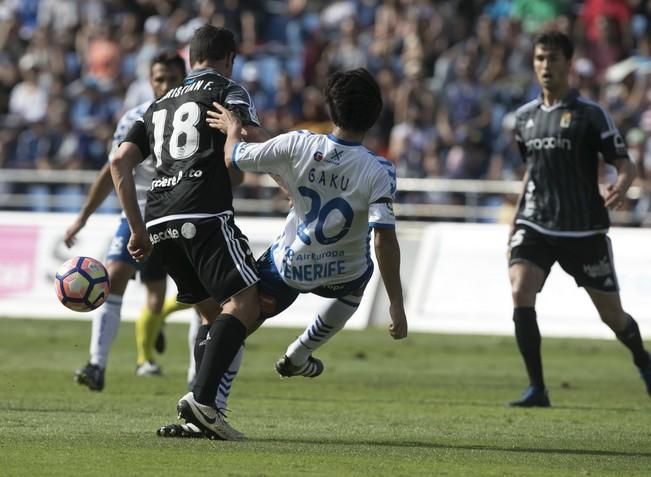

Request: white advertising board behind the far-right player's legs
left=407, top=224, right=651, bottom=338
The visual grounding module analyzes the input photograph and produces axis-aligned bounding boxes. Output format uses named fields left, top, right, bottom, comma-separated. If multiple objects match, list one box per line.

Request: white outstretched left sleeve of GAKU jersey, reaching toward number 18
left=231, top=133, right=293, bottom=175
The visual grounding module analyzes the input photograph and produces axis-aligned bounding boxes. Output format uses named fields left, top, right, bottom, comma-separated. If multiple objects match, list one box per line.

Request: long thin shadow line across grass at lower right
left=253, top=438, right=651, bottom=457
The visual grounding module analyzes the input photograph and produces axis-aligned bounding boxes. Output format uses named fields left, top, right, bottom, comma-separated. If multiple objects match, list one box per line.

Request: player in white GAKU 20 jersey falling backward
left=158, top=68, right=407, bottom=437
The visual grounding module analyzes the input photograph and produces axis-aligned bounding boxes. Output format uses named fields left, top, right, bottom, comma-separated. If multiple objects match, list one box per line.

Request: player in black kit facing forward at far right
left=509, top=31, right=651, bottom=407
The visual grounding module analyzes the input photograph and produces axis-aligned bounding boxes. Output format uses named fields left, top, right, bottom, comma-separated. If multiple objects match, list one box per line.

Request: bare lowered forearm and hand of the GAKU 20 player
left=374, top=227, right=408, bottom=340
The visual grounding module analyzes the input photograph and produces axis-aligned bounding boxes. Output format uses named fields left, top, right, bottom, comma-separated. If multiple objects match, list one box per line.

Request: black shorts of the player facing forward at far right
left=509, top=225, right=619, bottom=292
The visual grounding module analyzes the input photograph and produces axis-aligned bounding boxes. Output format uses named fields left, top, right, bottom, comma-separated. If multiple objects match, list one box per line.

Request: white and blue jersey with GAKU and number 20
left=232, top=131, right=396, bottom=291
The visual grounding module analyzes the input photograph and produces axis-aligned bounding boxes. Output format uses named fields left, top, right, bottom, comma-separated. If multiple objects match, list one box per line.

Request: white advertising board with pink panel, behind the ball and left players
left=0, top=212, right=379, bottom=328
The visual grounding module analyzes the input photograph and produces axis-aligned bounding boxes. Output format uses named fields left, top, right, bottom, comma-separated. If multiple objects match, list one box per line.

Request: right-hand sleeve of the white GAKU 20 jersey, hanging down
left=368, top=158, right=396, bottom=229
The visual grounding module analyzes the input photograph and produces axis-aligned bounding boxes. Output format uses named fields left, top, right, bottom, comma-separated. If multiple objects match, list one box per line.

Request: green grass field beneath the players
left=0, top=319, right=651, bottom=477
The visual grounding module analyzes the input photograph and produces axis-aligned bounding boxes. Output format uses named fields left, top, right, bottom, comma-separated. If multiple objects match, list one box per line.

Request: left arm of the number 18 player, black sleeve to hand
left=111, top=120, right=152, bottom=262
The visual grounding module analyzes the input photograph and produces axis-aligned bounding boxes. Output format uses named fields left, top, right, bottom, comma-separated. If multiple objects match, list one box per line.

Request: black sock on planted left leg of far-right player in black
left=513, top=307, right=545, bottom=389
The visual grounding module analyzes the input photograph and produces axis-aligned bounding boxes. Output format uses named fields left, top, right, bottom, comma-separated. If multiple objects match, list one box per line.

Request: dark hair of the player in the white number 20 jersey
left=324, top=68, right=382, bottom=132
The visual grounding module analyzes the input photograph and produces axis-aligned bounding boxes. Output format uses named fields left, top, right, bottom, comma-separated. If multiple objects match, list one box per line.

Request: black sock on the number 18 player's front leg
left=192, top=313, right=246, bottom=406
